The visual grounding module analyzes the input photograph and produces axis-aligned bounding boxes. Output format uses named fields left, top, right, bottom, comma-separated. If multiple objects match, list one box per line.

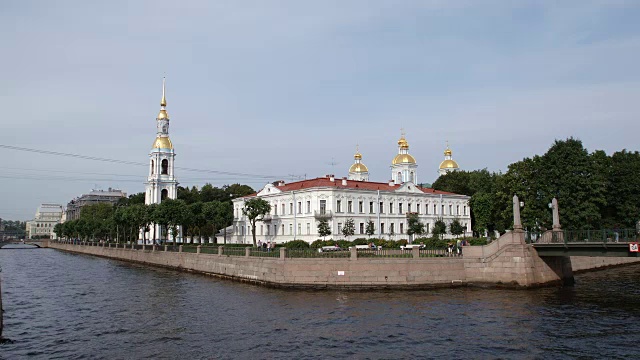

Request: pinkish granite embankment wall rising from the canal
left=49, top=233, right=640, bottom=289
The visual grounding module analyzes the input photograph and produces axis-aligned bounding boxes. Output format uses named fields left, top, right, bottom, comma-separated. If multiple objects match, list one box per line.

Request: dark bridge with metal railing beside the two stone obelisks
left=525, top=229, right=640, bottom=257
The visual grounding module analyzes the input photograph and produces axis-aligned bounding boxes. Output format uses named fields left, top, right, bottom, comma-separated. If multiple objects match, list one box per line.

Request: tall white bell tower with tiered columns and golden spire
left=139, top=79, right=182, bottom=243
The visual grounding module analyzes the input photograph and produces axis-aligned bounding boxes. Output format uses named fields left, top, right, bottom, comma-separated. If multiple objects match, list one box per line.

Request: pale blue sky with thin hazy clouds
left=0, top=0, right=640, bottom=220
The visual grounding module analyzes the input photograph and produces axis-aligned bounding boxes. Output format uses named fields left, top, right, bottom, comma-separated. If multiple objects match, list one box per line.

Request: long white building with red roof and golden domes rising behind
left=228, top=134, right=471, bottom=243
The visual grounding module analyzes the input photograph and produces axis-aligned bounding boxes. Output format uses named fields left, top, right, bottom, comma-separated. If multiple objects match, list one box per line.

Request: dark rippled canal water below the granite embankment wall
left=0, top=249, right=640, bottom=359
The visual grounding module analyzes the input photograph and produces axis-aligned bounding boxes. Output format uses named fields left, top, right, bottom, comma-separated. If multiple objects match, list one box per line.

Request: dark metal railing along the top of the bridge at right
left=525, top=229, right=640, bottom=244
